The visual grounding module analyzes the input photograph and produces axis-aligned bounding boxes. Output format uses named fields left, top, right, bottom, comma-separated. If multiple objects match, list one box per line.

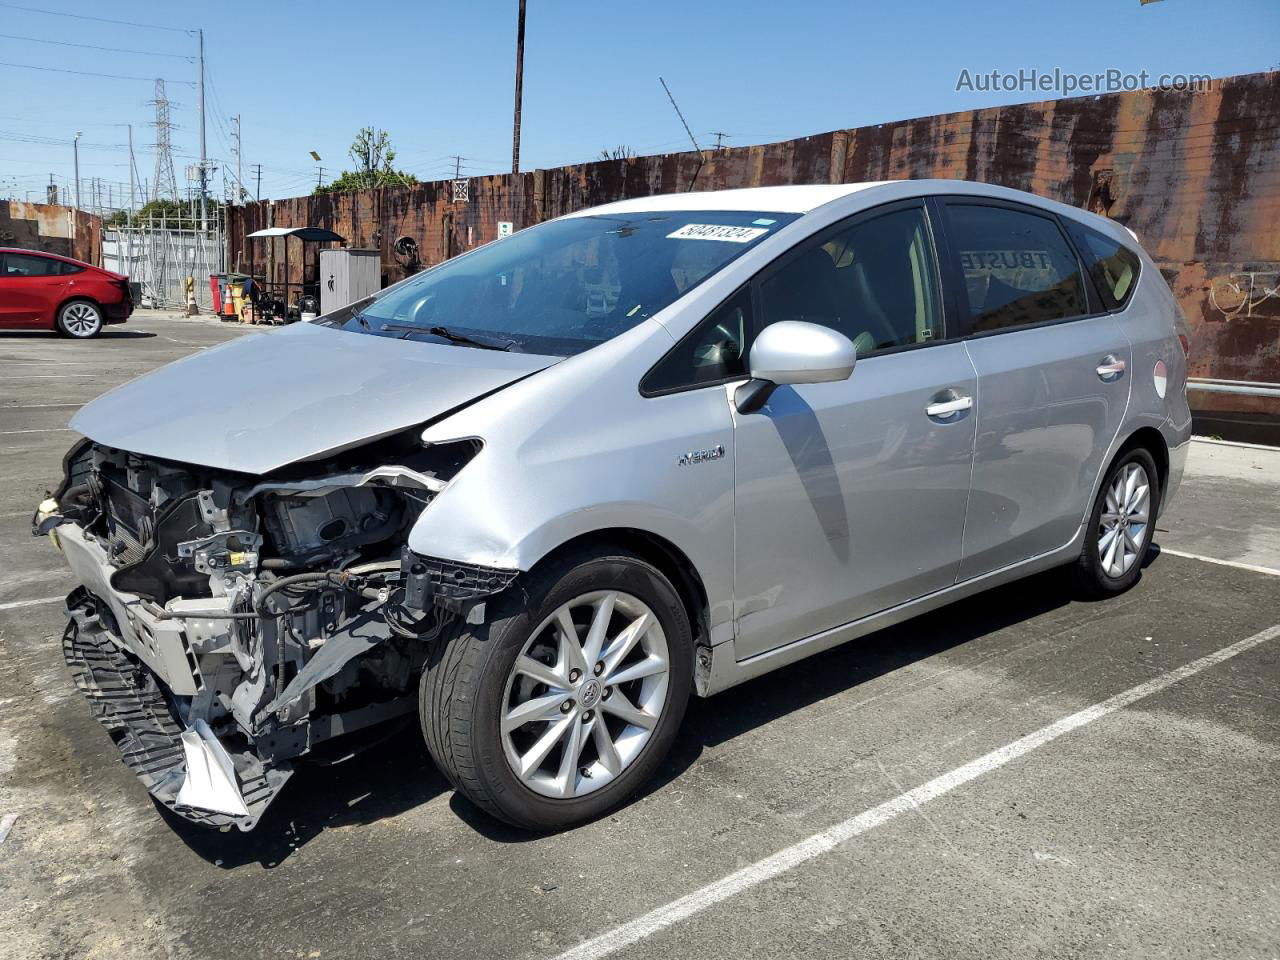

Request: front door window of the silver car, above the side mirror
left=760, top=207, right=942, bottom=356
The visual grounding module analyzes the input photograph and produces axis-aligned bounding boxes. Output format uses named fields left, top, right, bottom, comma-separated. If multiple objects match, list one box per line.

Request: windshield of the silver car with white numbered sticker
left=317, top=211, right=796, bottom=356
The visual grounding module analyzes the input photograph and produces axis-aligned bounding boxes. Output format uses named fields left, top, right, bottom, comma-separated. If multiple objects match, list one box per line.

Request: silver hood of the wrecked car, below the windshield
left=70, top=324, right=558, bottom=474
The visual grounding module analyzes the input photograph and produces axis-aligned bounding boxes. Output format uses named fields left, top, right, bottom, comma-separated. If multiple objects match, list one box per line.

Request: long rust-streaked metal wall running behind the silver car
left=228, top=72, right=1280, bottom=427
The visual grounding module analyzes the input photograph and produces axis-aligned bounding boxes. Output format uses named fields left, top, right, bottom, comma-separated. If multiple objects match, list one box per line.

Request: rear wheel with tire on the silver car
left=1075, top=447, right=1161, bottom=598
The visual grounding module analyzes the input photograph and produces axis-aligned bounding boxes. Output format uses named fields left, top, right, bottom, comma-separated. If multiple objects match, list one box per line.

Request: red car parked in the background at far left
left=0, top=247, right=133, bottom=339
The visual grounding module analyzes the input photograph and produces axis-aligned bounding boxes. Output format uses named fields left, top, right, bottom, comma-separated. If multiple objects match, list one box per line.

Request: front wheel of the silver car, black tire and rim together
left=419, top=548, right=694, bottom=831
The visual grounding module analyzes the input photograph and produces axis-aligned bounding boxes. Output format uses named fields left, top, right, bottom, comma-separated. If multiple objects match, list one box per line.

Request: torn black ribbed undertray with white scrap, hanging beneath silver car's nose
left=63, top=586, right=293, bottom=831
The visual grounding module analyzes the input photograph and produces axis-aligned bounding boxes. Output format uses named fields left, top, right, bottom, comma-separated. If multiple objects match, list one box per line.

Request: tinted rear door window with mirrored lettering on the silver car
left=947, top=204, right=1088, bottom=333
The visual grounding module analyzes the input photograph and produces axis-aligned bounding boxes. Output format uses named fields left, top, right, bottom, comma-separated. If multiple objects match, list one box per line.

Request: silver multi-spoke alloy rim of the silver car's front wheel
left=499, top=590, right=671, bottom=799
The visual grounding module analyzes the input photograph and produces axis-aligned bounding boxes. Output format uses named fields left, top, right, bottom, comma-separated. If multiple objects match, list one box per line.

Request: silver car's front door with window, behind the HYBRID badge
left=733, top=202, right=977, bottom=659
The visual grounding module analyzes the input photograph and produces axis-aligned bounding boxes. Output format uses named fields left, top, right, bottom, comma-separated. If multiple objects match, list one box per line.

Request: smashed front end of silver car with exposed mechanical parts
left=33, top=436, right=516, bottom=829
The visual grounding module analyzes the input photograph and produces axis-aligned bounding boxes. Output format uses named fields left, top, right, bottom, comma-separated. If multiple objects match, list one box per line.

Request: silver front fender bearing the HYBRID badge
left=408, top=323, right=733, bottom=626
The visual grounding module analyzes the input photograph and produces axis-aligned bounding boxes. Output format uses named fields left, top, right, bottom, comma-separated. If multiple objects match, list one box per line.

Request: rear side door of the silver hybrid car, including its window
left=940, top=198, right=1132, bottom=580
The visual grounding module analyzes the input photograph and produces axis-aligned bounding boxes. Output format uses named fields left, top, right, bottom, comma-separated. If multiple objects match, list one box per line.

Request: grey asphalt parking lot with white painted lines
left=0, top=315, right=1280, bottom=960
